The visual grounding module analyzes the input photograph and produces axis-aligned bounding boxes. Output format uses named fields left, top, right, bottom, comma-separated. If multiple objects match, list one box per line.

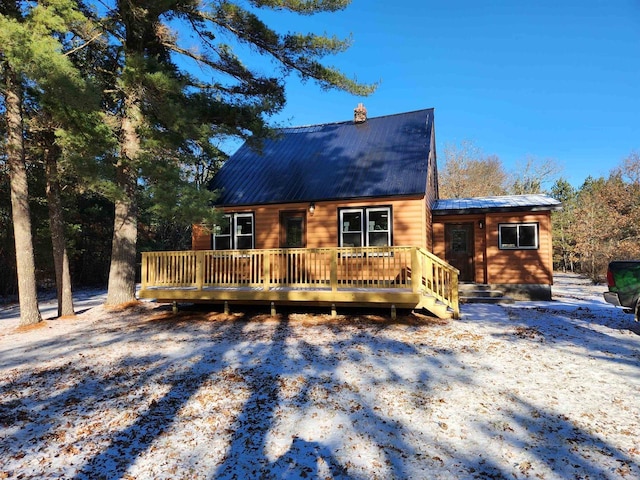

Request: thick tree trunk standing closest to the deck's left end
left=106, top=89, right=140, bottom=305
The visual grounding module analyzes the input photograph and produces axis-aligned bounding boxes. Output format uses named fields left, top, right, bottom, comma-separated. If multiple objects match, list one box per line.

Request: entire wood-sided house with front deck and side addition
left=141, top=104, right=560, bottom=316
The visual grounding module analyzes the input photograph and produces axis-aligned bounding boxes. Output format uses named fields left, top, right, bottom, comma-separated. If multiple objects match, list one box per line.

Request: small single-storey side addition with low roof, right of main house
left=432, top=195, right=561, bottom=300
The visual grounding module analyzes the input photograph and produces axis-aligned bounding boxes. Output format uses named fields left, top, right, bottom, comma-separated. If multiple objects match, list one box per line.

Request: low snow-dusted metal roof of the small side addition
left=432, top=194, right=562, bottom=215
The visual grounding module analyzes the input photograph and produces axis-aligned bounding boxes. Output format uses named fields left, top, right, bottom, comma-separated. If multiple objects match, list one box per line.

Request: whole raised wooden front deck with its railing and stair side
left=139, top=247, right=459, bottom=318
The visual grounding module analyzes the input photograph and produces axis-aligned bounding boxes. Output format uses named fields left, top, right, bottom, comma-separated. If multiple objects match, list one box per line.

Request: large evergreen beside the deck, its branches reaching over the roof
left=81, top=0, right=374, bottom=304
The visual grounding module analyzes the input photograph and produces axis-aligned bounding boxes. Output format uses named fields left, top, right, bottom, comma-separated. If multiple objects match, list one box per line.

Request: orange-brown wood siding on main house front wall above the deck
left=192, top=196, right=431, bottom=250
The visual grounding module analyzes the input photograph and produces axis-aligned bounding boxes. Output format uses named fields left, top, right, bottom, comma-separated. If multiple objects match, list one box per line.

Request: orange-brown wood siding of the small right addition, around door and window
left=433, top=212, right=553, bottom=285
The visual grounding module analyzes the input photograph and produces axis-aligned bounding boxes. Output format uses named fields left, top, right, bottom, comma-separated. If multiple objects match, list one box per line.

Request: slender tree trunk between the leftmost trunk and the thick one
left=44, top=132, right=75, bottom=317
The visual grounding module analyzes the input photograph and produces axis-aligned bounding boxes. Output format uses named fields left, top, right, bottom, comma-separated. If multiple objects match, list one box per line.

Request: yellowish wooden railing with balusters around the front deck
left=142, top=247, right=458, bottom=316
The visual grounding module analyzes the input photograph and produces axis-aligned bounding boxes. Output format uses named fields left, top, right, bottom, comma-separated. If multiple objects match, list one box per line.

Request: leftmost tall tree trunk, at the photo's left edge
left=4, top=65, right=42, bottom=325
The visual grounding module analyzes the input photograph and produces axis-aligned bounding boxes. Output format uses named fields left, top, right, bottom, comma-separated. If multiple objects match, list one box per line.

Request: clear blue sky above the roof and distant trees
left=242, top=0, right=640, bottom=187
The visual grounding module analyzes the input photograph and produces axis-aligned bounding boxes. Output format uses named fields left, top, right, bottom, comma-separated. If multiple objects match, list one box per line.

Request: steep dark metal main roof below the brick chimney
left=209, top=109, right=433, bottom=206
